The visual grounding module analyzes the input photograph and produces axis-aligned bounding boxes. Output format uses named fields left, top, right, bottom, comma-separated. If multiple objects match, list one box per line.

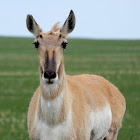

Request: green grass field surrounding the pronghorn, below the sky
left=0, top=37, right=140, bottom=140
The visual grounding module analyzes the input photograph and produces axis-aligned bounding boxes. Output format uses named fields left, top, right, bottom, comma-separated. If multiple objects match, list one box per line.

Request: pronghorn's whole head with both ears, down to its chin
left=26, top=10, right=75, bottom=84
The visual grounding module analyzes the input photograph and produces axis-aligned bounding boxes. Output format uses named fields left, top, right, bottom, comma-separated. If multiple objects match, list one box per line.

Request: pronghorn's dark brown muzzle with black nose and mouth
left=44, top=51, right=57, bottom=83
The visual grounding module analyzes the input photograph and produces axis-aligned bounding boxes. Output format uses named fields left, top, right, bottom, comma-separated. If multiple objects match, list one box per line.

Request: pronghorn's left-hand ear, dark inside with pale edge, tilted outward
left=26, top=15, right=42, bottom=37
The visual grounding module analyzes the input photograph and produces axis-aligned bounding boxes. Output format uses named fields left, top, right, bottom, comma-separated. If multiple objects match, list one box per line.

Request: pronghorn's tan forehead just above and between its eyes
left=36, top=31, right=66, bottom=46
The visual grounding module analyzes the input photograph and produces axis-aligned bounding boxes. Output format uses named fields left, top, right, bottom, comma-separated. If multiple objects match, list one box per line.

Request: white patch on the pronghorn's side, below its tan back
left=90, top=105, right=112, bottom=140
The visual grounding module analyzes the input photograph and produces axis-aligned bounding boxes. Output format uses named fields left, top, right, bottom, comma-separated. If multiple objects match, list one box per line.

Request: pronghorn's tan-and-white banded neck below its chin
left=38, top=61, right=69, bottom=125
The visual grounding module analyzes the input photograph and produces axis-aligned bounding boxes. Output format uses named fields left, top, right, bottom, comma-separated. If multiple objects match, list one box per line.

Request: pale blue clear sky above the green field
left=0, top=0, right=140, bottom=39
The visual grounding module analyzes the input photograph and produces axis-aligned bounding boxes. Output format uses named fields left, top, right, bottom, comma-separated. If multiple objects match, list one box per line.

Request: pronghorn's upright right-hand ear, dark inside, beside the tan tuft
left=60, top=10, right=75, bottom=37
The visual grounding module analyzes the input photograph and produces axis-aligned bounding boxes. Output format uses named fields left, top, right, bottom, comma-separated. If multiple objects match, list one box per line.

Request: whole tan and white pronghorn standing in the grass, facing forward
left=26, top=10, right=125, bottom=140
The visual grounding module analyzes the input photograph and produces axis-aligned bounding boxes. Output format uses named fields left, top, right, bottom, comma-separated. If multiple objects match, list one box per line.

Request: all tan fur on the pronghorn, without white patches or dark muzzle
left=28, top=11, right=125, bottom=140
